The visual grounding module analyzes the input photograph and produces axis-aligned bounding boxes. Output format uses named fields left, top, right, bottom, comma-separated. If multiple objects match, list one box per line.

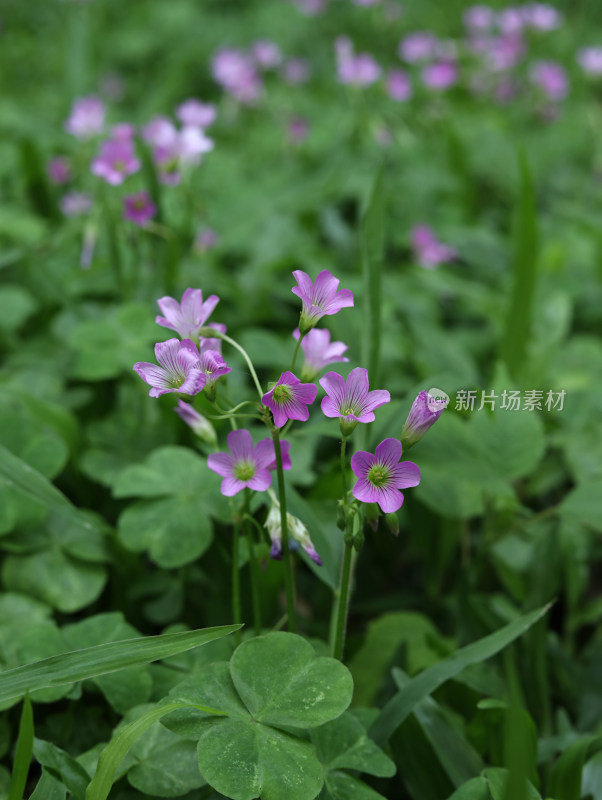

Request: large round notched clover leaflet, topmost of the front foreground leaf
left=230, top=633, right=353, bottom=728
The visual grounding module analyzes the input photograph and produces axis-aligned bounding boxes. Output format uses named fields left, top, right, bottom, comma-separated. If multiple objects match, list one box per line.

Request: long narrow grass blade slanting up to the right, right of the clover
left=369, top=605, right=550, bottom=744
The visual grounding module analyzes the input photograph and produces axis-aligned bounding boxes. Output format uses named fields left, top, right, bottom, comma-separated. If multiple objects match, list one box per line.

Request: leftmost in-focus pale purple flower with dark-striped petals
left=134, top=339, right=207, bottom=397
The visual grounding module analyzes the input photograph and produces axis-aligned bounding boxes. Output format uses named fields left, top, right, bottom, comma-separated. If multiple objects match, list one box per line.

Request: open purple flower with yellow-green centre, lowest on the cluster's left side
left=207, top=428, right=273, bottom=497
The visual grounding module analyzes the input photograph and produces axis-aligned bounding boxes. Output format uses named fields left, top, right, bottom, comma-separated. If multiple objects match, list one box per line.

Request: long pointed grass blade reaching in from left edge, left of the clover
left=0, top=625, right=240, bottom=703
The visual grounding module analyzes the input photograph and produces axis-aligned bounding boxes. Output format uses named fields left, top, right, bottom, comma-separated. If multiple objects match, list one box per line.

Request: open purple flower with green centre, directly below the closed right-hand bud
left=351, top=439, right=420, bottom=514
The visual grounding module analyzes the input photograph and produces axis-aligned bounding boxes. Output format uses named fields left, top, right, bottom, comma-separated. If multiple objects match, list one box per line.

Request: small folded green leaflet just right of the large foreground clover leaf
left=311, top=712, right=396, bottom=778
